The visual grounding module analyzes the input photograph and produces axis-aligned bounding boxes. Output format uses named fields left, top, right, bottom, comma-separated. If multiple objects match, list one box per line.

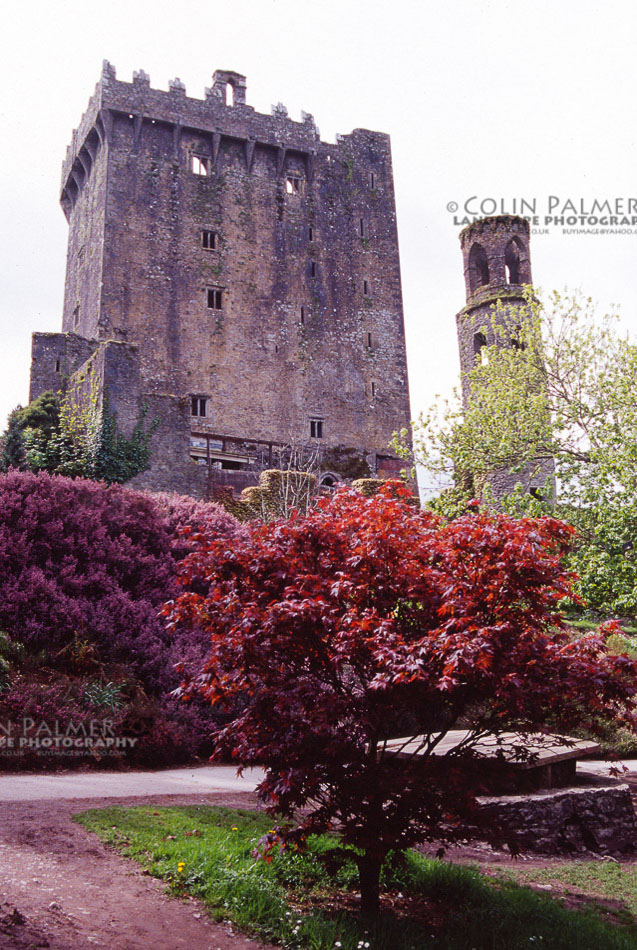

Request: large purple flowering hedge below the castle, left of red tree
left=0, top=471, right=246, bottom=768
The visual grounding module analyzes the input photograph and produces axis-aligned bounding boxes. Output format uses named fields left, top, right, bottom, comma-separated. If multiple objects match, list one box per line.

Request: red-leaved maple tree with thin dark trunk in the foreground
left=167, top=483, right=637, bottom=912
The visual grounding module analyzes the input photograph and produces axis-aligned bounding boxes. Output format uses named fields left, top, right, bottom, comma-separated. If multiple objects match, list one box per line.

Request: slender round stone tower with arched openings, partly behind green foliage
left=456, top=215, right=554, bottom=497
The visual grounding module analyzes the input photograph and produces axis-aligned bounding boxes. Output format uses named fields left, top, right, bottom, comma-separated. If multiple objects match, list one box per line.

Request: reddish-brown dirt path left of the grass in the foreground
left=0, top=793, right=278, bottom=950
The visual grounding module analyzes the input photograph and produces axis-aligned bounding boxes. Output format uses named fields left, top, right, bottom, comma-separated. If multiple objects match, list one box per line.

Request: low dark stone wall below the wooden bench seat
left=479, top=781, right=637, bottom=854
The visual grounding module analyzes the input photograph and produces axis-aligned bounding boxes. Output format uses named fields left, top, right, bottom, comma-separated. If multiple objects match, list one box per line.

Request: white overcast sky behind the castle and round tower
left=0, top=0, right=637, bottom=438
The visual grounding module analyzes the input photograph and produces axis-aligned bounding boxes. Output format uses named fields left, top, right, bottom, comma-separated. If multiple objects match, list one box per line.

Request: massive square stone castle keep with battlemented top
left=30, top=63, right=410, bottom=497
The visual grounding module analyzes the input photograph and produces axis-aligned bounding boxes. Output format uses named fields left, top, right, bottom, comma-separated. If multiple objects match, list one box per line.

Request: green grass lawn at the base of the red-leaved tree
left=75, top=806, right=637, bottom=950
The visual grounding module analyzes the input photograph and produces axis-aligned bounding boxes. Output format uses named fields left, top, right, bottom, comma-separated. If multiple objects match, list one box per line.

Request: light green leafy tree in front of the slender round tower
left=398, top=291, right=637, bottom=615
